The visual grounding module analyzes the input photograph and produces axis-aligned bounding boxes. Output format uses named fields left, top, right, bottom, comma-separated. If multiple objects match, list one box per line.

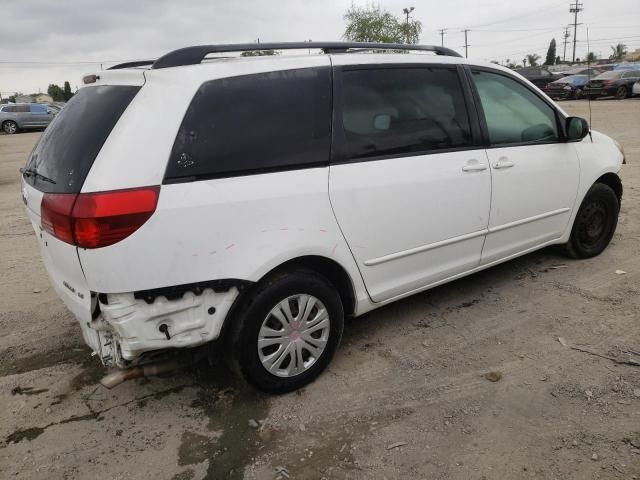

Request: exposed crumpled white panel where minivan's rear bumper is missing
left=83, top=285, right=242, bottom=368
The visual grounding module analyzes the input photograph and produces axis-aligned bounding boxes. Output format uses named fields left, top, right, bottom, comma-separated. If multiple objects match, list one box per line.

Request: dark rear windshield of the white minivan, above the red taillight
left=25, top=85, right=140, bottom=193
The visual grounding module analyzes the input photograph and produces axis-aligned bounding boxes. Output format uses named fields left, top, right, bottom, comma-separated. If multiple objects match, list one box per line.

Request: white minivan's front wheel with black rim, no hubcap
left=564, top=183, right=620, bottom=258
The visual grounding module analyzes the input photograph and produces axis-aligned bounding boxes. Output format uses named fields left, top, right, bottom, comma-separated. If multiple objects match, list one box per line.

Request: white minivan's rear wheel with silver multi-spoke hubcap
left=227, top=269, right=344, bottom=393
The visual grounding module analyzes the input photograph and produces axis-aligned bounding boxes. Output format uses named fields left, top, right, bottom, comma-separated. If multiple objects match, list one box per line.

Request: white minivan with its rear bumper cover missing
left=22, top=43, right=624, bottom=392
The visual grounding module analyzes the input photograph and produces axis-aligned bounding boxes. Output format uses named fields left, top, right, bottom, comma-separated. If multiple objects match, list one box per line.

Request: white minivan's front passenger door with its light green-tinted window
left=472, top=70, right=580, bottom=264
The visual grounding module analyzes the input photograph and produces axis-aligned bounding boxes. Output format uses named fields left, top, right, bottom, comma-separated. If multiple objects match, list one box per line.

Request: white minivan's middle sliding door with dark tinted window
left=329, top=65, right=491, bottom=302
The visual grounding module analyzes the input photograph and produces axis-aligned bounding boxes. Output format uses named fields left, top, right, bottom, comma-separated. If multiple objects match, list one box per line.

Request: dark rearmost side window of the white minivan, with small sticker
left=165, top=68, right=331, bottom=181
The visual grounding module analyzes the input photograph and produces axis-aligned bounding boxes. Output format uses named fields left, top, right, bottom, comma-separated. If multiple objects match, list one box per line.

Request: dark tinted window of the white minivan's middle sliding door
left=341, top=67, right=472, bottom=159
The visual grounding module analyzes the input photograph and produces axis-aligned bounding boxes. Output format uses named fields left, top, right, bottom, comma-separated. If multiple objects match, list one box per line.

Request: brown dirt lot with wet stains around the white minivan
left=0, top=99, right=640, bottom=480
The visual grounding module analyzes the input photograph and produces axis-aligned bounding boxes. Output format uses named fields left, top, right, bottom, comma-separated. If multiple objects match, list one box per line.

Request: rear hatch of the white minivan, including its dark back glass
left=22, top=79, right=144, bottom=334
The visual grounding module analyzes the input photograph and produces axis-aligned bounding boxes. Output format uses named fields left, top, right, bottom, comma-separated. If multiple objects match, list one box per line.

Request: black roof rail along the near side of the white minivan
left=150, top=42, right=462, bottom=69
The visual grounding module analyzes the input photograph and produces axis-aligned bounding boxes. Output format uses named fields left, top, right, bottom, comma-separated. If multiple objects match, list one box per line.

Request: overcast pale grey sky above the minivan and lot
left=0, top=0, right=640, bottom=97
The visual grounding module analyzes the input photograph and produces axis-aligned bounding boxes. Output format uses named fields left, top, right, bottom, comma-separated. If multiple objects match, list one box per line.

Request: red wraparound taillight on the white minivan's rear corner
left=41, top=186, right=160, bottom=248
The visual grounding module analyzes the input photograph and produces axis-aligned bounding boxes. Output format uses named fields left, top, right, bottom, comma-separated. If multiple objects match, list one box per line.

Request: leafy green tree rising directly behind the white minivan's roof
left=344, top=4, right=422, bottom=44
